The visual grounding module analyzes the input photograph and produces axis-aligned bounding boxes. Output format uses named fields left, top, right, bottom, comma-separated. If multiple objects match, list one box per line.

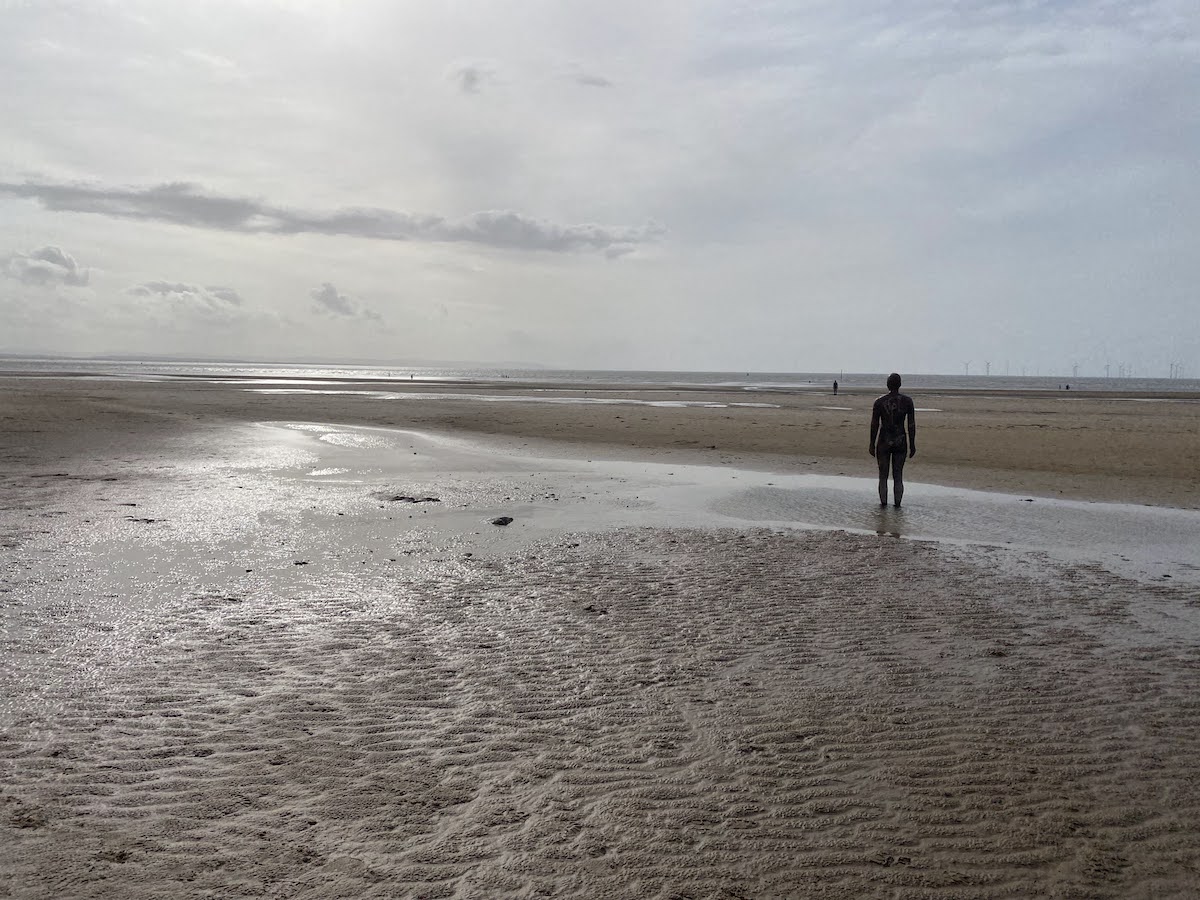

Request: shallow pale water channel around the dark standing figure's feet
left=267, top=424, right=1200, bottom=584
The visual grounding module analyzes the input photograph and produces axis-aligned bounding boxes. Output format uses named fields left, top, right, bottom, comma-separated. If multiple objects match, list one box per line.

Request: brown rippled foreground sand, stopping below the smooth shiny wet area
left=0, top=530, right=1200, bottom=898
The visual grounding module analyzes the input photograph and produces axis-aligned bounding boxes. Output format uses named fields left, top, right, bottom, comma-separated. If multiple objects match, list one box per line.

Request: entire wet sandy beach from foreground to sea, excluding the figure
left=0, top=378, right=1200, bottom=898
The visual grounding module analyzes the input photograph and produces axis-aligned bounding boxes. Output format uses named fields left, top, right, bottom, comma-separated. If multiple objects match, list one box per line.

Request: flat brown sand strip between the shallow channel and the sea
left=7, top=377, right=1200, bottom=509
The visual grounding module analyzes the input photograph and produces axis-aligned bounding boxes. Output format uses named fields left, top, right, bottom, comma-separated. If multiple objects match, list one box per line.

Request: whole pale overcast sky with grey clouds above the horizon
left=0, top=0, right=1200, bottom=377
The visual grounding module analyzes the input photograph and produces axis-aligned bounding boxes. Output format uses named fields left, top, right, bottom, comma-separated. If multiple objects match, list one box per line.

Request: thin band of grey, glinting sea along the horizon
left=0, top=356, right=1200, bottom=394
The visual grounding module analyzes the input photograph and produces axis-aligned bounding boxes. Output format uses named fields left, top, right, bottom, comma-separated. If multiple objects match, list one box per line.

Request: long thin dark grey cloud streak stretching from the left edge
left=0, top=181, right=665, bottom=256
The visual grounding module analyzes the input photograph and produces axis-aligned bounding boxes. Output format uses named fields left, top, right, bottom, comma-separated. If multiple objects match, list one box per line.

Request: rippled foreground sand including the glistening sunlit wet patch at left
left=0, top=384, right=1200, bottom=898
